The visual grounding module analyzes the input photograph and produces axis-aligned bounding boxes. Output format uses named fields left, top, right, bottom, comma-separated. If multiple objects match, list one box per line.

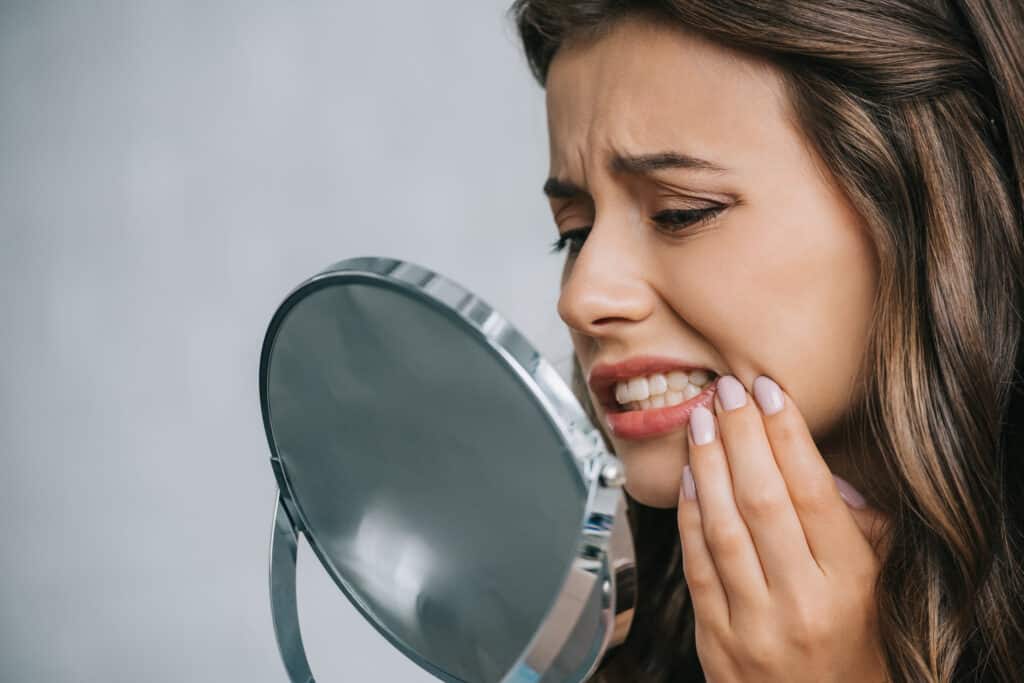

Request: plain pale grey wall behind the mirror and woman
left=0, top=0, right=569, bottom=683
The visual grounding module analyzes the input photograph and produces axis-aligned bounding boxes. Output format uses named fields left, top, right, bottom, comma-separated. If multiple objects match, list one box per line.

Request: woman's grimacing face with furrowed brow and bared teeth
left=545, top=17, right=878, bottom=508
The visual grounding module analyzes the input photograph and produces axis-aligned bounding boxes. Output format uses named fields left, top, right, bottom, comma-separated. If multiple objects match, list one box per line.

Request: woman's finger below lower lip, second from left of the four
left=686, top=405, right=768, bottom=609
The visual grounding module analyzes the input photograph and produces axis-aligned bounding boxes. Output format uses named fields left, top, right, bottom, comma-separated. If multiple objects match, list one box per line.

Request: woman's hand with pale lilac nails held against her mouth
left=679, top=376, right=887, bottom=683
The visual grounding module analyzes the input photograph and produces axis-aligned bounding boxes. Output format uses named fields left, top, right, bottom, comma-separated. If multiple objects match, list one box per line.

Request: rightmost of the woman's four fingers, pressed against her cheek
left=754, top=375, right=874, bottom=572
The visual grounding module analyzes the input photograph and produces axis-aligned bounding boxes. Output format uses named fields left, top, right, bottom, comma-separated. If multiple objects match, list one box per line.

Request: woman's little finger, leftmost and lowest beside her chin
left=677, top=465, right=729, bottom=625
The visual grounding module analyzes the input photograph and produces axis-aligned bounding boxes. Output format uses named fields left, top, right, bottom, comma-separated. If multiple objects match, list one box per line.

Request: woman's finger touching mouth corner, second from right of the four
left=715, top=375, right=820, bottom=592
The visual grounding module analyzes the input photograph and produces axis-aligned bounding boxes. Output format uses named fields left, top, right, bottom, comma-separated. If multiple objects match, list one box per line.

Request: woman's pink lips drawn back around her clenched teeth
left=587, top=355, right=721, bottom=439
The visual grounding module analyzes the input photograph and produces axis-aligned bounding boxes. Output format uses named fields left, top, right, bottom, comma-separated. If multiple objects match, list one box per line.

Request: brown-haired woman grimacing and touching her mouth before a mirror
left=512, top=0, right=1024, bottom=683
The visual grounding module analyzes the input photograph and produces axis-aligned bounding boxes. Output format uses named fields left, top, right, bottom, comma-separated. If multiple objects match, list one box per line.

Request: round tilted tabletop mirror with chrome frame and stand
left=259, top=257, right=635, bottom=683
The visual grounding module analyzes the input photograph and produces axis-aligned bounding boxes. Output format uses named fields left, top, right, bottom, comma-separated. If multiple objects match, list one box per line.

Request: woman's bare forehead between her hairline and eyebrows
left=547, top=16, right=793, bottom=181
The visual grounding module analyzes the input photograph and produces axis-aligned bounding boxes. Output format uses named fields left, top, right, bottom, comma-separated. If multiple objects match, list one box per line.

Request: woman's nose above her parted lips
left=558, top=221, right=654, bottom=337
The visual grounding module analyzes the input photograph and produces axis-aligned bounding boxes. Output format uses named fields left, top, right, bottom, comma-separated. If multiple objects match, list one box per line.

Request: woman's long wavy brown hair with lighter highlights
left=509, top=0, right=1024, bottom=683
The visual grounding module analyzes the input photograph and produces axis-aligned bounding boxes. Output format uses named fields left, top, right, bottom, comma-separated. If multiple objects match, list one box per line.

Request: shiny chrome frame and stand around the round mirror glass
left=259, top=257, right=636, bottom=683
